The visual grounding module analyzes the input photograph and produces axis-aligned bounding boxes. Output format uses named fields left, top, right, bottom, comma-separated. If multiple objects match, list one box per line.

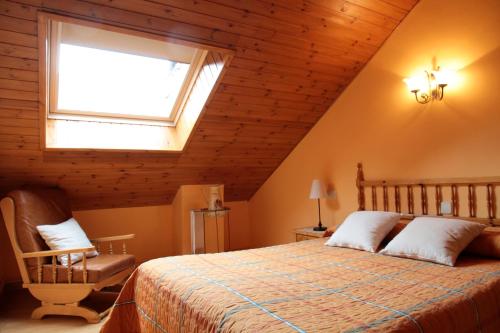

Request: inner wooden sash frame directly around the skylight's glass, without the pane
left=45, top=14, right=208, bottom=127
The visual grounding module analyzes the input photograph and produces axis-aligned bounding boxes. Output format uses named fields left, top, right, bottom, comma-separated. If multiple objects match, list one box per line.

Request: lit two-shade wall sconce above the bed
left=403, top=67, right=449, bottom=104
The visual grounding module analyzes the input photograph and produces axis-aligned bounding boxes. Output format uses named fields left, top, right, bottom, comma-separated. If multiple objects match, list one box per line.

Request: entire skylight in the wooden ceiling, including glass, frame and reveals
left=37, top=11, right=234, bottom=153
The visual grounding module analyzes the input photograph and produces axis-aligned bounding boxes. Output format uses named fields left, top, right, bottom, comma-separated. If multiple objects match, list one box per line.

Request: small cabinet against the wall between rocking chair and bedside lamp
left=191, top=207, right=231, bottom=254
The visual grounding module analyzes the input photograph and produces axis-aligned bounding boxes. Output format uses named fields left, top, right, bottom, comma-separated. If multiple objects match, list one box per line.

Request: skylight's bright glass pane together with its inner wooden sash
left=49, top=21, right=206, bottom=125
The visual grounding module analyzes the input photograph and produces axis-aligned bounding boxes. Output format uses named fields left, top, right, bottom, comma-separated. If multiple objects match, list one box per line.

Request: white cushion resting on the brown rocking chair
left=36, top=218, right=99, bottom=267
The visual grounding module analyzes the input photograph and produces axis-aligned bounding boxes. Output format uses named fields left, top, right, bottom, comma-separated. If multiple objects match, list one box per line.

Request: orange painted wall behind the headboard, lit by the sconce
left=250, top=0, right=500, bottom=246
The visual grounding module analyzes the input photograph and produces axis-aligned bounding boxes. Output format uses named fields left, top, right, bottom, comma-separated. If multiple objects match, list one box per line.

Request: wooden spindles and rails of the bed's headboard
left=356, top=163, right=500, bottom=226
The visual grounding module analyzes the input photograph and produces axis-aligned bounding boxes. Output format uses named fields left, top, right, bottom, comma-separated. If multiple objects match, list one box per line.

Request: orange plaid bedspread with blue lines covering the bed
left=101, top=239, right=500, bottom=333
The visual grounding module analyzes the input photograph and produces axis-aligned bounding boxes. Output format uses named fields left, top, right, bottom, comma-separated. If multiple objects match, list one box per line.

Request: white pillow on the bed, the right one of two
left=380, top=217, right=486, bottom=266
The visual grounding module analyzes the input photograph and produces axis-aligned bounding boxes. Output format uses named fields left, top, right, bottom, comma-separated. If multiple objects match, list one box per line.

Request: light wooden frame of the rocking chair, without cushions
left=0, top=197, right=135, bottom=323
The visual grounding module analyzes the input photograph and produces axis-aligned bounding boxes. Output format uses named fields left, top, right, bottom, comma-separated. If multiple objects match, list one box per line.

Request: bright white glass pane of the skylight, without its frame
left=57, top=43, right=190, bottom=119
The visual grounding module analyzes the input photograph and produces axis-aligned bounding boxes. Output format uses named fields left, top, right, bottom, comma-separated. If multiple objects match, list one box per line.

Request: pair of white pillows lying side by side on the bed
left=326, top=211, right=485, bottom=266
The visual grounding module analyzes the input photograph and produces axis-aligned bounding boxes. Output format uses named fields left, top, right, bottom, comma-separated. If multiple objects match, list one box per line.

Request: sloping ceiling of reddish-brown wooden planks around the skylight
left=0, top=0, right=418, bottom=209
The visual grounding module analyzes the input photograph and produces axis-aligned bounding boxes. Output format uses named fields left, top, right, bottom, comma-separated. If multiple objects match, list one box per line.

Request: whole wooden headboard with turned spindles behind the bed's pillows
left=356, top=163, right=500, bottom=225
